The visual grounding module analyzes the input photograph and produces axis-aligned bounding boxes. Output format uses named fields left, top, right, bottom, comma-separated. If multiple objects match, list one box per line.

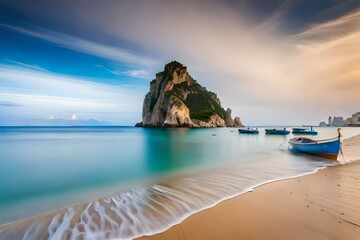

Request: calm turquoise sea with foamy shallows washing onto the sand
left=0, top=127, right=360, bottom=239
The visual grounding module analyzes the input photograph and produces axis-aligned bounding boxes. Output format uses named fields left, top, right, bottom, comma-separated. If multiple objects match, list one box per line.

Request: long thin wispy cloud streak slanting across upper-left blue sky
left=0, top=24, right=158, bottom=67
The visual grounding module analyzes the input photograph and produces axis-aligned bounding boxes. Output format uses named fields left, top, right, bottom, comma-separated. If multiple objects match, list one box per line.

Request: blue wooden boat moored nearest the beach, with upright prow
left=289, top=128, right=341, bottom=160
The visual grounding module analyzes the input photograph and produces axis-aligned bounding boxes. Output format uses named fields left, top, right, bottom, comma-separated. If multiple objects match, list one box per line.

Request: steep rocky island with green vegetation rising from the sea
left=136, top=61, right=243, bottom=128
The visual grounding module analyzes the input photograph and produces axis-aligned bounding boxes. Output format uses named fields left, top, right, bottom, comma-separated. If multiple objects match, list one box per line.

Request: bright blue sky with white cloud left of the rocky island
left=0, top=2, right=159, bottom=125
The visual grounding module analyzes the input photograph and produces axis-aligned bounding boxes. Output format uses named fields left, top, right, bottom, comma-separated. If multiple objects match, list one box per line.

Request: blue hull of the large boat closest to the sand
left=289, top=139, right=340, bottom=160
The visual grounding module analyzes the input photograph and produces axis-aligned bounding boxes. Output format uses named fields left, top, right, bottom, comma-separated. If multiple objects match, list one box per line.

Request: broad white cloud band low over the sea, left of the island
left=0, top=65, right=145, bottom=124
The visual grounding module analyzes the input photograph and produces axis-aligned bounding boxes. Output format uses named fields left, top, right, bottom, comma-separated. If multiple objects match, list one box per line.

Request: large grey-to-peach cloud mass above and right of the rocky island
left=1, top=0, right=360, bottom=124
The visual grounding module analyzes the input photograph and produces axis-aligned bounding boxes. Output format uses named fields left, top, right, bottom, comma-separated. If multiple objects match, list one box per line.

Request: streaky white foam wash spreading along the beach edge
left=0, top=153, right=337, bottom=240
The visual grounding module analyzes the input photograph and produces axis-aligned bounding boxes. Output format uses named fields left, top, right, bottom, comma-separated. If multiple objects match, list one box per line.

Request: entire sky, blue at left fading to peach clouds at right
left=0, top=0, right=360, bottom=126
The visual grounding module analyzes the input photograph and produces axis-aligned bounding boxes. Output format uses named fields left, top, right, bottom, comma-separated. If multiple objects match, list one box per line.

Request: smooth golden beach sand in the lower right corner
left=141, top=135, right=360, bottom=240
